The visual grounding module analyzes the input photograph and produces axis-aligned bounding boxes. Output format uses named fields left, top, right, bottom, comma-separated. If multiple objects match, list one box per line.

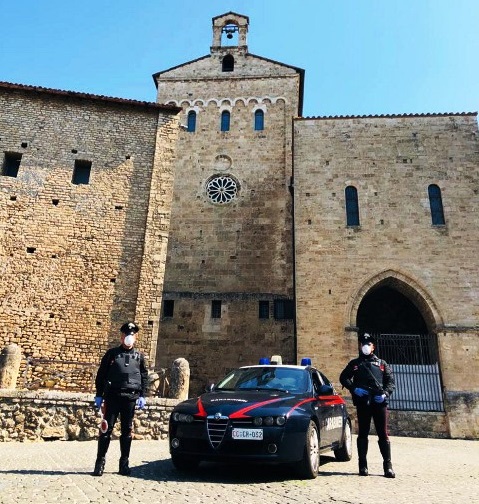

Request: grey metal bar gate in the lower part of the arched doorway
left=374, top=334, right=444, bottom=411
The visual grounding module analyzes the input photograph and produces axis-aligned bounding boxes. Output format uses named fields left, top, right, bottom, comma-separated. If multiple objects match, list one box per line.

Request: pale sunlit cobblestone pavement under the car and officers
left=0, top=437, right=479, bottom=504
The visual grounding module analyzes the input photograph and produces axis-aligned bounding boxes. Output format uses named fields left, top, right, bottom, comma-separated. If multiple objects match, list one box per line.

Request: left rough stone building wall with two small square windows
left=0, top=84, right=178, bottom=385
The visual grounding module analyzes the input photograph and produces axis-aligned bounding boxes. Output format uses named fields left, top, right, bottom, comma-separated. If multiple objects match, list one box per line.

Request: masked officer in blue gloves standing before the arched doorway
left=339, top=333, right=396, bottom=478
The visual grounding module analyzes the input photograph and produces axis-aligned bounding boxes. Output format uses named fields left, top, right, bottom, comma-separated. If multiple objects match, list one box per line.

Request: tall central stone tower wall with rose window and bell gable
left=154, top=14, right=302, bottom=391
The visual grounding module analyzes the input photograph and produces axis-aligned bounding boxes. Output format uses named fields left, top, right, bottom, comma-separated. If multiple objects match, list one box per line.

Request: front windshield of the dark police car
left=215, top=366, right=309, bottom=393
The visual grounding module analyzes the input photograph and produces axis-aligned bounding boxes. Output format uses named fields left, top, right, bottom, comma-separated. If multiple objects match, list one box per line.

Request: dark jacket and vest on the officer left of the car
left=95, top=345, right=148, bottom=398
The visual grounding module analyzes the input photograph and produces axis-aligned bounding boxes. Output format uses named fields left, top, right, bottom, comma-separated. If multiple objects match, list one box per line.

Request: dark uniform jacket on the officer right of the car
left=339, top=354, right=395, bottom=405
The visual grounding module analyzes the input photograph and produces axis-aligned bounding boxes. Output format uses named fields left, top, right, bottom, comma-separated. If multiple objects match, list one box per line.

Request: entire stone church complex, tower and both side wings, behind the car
left=0, top=12, right=479, bottom=438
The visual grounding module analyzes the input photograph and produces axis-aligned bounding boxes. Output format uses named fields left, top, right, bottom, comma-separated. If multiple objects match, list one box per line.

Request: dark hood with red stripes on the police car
left=175, top=390, right=307, bottom=418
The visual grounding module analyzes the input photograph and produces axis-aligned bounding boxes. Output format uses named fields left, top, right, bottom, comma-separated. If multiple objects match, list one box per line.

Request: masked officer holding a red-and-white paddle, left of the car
left=93, top=322, right=148, bottom=476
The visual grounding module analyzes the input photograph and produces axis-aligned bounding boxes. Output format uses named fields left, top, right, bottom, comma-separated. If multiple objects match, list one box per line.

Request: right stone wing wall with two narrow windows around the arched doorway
left=294, top=114, right=479, bottom=437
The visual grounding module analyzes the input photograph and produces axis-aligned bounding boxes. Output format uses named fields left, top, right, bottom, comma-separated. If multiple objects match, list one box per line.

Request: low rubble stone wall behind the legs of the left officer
left=0, top=389, right=180, bottom=441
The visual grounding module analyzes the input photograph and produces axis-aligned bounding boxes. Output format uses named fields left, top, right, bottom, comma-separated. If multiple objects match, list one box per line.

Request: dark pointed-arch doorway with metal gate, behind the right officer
left=356, top=275, right=444, bottom=411
